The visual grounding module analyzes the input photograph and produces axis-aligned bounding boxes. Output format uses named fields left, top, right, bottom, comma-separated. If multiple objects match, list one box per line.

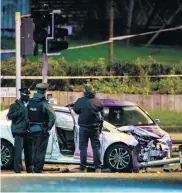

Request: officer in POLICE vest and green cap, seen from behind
left=28, top=83, right=55, bottom=173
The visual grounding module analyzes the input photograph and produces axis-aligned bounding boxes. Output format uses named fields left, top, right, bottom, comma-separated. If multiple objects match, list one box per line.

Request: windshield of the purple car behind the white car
left=104, top=106, right=154, bottom=126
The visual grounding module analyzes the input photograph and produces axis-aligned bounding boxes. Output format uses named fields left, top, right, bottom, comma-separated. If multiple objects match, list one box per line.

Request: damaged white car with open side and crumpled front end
left=0, top=107, right=170, bottom=172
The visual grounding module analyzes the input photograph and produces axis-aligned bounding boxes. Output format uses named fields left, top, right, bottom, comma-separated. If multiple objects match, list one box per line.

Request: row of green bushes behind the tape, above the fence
left=1, top=56, right=182, bottom=94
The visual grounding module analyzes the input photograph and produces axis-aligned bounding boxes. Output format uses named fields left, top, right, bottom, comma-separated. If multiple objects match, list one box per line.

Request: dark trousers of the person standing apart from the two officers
left=79, top=127, right=101, bottom=170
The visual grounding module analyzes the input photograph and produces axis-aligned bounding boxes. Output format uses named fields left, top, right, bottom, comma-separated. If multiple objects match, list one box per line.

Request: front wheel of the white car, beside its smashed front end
left=105, top=144, right=133, bottom=172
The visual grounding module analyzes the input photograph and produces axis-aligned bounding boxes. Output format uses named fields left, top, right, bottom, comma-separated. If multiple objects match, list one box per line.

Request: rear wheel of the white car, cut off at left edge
left=1, top=140, right=13, bottom=169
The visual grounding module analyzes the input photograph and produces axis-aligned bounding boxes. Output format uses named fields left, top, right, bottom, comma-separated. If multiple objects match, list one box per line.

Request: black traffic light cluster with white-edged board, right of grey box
left=31, top=6, right=68, bottom=55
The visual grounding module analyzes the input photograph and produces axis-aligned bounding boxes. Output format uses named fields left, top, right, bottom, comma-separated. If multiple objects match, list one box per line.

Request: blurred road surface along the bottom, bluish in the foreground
left=1, top=172, right=182, bottom=193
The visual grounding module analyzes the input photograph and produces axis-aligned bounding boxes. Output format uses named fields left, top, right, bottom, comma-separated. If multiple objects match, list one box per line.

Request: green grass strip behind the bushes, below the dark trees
left=1, top=37, right=182, bottom=65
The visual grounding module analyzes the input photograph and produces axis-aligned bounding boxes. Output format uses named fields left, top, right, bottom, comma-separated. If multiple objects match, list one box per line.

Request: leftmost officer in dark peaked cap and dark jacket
left=7, top=88, right=32, bottom=173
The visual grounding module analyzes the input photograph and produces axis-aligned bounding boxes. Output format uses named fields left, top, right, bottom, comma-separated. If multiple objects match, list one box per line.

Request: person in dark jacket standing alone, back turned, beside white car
left=73, top=85, right=103, bottom=172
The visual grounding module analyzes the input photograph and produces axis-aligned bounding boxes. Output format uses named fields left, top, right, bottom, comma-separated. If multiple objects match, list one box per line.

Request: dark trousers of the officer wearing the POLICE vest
left=31, top=132, right=49, bottom=173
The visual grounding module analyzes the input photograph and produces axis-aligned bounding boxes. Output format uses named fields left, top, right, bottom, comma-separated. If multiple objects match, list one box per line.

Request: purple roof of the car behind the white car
left=101, top=99, right=136, bottom=107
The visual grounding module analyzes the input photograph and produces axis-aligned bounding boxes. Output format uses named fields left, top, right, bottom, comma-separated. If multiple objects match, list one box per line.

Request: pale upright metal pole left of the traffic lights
left=15, top=12, right=21, bottom=99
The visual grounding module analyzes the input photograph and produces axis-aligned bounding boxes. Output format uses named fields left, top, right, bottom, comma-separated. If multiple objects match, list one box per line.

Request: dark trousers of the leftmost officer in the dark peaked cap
left=14, top=134, right=32, bottom=173
